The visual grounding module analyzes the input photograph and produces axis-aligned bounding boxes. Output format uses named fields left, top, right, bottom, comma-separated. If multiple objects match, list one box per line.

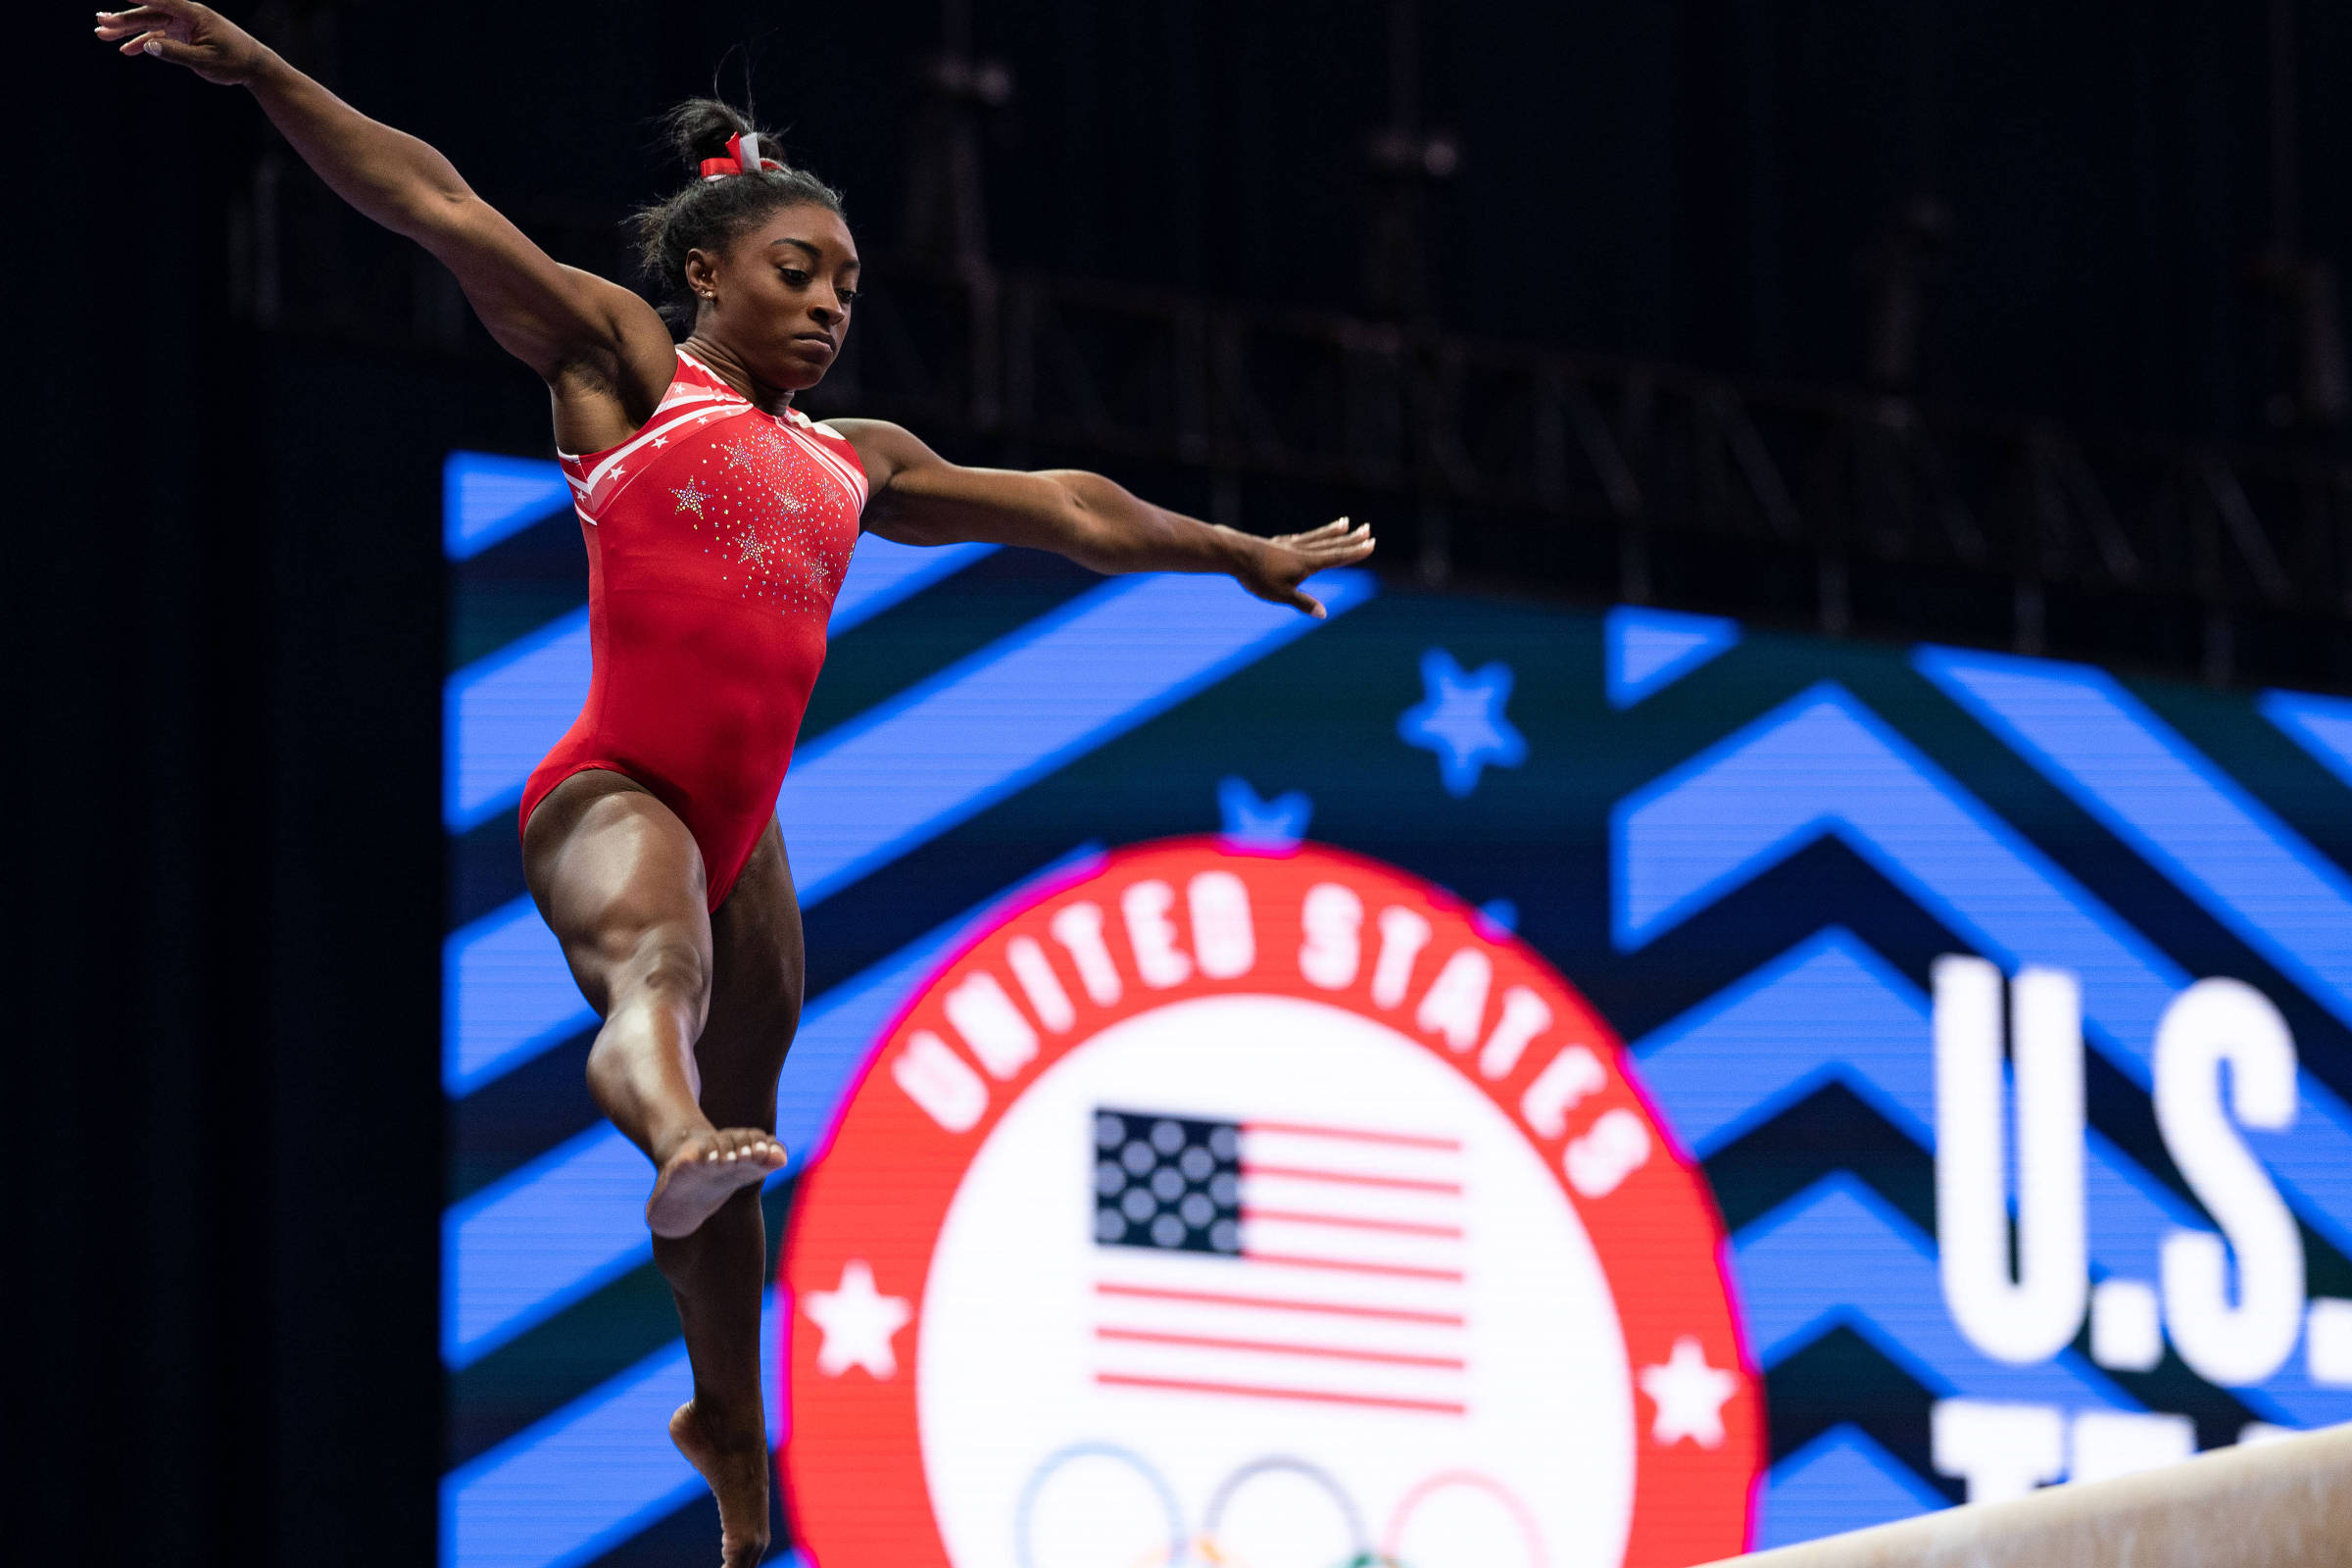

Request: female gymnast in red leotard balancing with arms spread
left=96, top=0, right=1371, bottom=1568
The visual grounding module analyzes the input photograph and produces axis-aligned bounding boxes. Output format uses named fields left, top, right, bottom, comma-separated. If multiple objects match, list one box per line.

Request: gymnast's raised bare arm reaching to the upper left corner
left=96, top=0, right=675, bottom=441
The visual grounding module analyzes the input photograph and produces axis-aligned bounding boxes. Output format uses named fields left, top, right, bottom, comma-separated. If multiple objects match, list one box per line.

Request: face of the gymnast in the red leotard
left=687, top=202, right=858, bottom=393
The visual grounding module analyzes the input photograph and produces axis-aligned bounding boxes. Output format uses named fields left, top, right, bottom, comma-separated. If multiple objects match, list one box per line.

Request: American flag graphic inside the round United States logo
left=1094, top=1107, right=1470, bottom=1417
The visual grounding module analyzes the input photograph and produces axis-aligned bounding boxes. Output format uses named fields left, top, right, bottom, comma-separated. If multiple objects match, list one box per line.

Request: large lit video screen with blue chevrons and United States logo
left=442, top=454, right=2352, bottom=1568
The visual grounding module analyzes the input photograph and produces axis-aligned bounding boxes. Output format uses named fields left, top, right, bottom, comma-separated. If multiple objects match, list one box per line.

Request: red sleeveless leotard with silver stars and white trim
left=522, top=348, right=865, bottom=909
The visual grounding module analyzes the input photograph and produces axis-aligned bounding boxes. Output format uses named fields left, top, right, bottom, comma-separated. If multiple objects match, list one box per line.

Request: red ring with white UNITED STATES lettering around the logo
left=776, top=837, right=1764, bottom=1568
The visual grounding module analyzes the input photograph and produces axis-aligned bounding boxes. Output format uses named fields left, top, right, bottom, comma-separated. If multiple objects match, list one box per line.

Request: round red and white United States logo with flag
left=781, top=839, right=1764, bottom=1568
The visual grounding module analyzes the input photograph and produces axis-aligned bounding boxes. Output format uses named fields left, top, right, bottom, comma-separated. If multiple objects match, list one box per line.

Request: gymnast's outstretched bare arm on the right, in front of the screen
left=828, top=418, right=1371, bottom=618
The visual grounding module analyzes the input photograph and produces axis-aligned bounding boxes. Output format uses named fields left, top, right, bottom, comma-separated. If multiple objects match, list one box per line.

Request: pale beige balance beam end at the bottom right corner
left=1712, top=1425, right=2352, bottom=1568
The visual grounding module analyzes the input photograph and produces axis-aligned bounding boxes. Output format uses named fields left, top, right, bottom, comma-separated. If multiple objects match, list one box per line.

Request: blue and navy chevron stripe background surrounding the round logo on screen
left=442, top=441, right=2352, bottom=1568
